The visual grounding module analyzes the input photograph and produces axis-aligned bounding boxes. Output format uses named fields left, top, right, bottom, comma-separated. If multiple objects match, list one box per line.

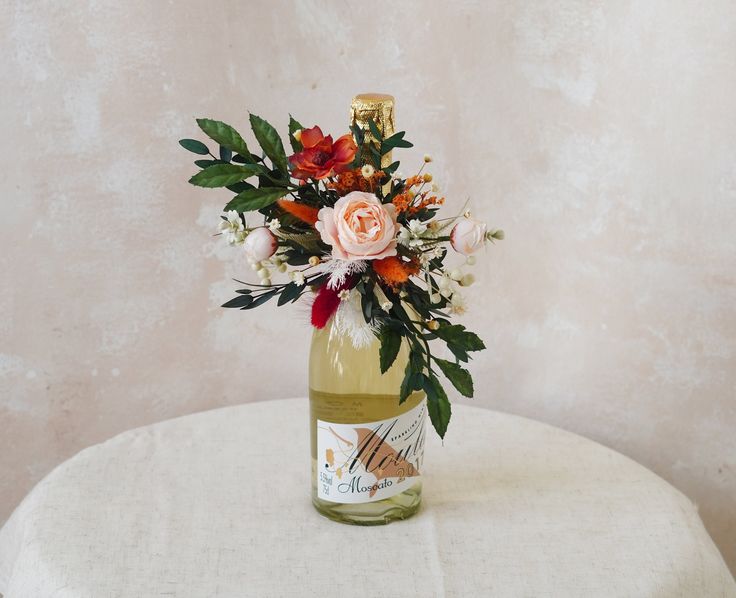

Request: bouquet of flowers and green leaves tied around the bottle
left=179, top=114, right=503, bottom=437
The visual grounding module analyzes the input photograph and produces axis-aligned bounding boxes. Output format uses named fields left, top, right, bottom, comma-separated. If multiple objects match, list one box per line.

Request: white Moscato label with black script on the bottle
left=317, top=401, right=427, bottom=503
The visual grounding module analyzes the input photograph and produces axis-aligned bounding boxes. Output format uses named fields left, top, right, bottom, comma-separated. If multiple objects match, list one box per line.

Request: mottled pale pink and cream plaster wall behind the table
left=0, top=0, right=736, bottom=567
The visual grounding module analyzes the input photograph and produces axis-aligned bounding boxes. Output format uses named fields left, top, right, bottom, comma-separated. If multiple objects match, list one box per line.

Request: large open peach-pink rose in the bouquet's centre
left=314, top=191, right=397, bottom=260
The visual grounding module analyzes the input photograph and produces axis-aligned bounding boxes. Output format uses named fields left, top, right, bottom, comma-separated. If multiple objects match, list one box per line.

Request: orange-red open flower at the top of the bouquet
left=289, top=126, right=358, bottom=180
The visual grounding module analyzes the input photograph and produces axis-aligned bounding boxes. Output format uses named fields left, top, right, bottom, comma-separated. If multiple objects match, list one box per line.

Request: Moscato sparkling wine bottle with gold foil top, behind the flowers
left=309, top=94, right=426, bottom=525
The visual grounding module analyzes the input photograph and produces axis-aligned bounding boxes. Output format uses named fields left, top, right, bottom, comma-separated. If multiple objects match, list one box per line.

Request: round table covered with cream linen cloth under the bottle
left=0, top=399, right=736, bottom=598
